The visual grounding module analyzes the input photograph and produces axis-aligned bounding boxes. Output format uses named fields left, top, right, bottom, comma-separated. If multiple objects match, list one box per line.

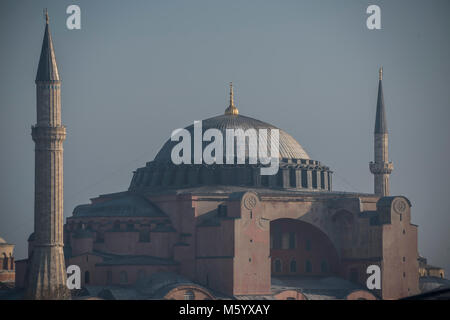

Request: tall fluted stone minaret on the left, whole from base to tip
left=25, top=12, right=70, bottom=299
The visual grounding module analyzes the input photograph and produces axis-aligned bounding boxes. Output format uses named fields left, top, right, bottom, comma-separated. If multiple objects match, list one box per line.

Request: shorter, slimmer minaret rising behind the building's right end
left=369, top=68, right=394, bottom=197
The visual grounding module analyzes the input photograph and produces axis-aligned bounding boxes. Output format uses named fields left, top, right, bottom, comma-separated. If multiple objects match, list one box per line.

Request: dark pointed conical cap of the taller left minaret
left=36, top=9, right=60, bottom=81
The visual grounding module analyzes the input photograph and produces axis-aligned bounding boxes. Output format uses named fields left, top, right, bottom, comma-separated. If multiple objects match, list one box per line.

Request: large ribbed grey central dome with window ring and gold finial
left=129, top=84, right=332, bottom=191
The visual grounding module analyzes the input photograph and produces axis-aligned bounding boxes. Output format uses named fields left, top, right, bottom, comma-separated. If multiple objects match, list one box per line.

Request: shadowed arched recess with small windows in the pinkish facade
left=270, top=218, right=339, bottom=276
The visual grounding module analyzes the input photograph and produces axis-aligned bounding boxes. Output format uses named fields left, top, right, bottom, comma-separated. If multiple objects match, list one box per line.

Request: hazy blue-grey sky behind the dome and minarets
left=0, top=0, right=450, bottom=272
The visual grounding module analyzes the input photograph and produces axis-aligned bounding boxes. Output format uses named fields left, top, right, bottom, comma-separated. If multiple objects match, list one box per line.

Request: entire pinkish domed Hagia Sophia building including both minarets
left=0, top=12, right=450, bottom=300
